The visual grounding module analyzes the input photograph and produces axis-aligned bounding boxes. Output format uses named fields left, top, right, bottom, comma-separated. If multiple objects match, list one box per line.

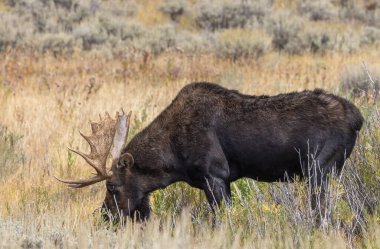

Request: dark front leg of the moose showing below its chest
left=203, top=177, right=231, bottom=213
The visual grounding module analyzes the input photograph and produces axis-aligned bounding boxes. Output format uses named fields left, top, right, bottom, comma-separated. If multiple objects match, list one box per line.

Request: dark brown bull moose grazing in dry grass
left=58, top=83, right=363, bottom=220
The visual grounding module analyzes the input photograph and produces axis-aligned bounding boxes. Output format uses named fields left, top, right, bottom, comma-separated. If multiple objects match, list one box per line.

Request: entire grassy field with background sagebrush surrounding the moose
left=0, top=0, right=380, bottom=249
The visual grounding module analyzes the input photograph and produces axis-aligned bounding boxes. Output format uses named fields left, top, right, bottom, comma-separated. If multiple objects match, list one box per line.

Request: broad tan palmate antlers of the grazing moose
left=55, top=111, right=131, bottom=188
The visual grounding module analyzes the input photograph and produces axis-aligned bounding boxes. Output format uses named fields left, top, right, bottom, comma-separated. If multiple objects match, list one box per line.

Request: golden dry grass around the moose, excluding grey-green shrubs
left=0, top=48, right=380, bottom=248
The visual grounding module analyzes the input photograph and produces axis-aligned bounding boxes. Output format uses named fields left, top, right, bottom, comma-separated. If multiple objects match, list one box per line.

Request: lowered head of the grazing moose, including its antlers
left=55, top=111, right=150, bottom=221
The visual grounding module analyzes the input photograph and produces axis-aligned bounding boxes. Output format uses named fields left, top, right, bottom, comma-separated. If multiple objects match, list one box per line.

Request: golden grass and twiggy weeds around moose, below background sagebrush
left=0, top=49, right=380, bottom=248
